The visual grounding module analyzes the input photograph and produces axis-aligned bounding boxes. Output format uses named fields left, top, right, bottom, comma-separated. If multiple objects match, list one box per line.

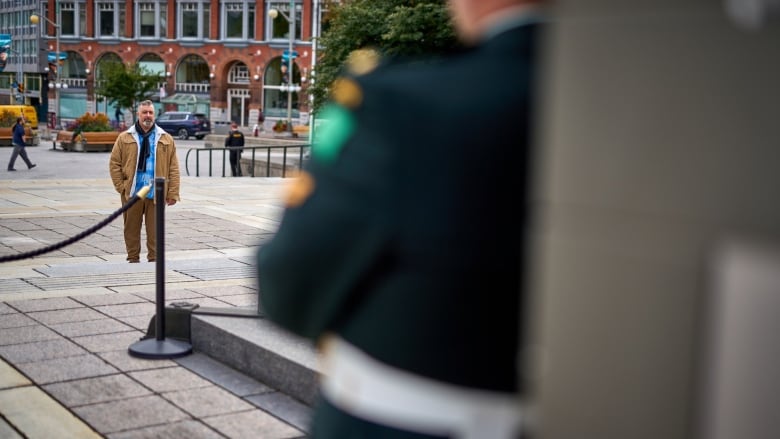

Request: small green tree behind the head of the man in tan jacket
left=95, top=62, right=161, bottom=122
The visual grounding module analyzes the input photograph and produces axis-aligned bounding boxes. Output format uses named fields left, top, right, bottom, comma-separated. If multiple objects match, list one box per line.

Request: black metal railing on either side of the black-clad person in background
left=184, top=143, right=311, bottom=178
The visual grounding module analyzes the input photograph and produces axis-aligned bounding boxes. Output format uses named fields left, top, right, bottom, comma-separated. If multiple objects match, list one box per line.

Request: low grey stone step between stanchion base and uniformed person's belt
left=190, top=308, right=320, bottom=406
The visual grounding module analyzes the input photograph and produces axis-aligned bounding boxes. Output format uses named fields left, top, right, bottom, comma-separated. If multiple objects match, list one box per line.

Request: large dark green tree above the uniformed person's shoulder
left=310, top=0, right=458, bottom=113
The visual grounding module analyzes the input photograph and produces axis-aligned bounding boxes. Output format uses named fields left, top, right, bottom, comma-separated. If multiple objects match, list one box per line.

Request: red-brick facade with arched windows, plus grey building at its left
left=0, top=0, right=326, bottom=128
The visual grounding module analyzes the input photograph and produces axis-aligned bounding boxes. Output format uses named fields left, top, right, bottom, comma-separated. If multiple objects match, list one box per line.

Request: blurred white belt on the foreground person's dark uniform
left=321, top=336, right=521, bottom=439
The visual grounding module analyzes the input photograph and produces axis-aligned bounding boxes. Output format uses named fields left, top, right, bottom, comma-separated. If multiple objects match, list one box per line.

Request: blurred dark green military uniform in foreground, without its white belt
left=258, top=11, right=536, bottom=438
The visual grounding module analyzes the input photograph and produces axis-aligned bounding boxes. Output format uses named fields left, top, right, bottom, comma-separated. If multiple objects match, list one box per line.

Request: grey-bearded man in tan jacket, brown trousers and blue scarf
left=108, top=101, right=180, bottom=262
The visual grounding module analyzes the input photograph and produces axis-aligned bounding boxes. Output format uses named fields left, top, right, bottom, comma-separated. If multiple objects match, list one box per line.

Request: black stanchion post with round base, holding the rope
left=127, top=178, right=192, bottom=359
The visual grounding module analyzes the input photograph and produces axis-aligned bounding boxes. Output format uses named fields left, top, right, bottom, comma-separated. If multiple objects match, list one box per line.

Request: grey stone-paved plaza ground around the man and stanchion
left=0, top=141, right=309, bottom=439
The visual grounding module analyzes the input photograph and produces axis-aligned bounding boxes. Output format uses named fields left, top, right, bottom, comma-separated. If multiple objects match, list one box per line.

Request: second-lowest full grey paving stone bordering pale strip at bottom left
left=43, top=374, right=152, bottom=407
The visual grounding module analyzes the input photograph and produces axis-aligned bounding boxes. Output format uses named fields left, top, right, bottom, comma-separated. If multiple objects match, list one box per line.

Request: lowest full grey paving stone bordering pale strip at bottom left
left=72, top=395, right=190, bottom=434
